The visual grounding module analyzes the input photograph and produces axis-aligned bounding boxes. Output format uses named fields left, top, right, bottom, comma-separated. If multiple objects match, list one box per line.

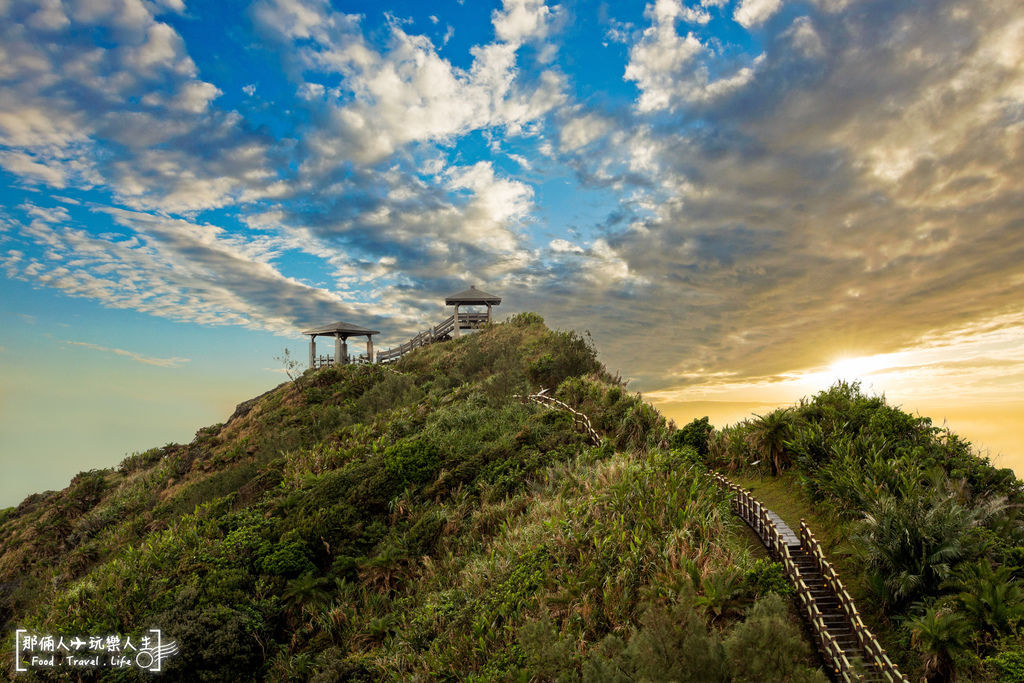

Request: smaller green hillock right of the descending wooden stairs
left=705, top=383, right=1024, bottom=681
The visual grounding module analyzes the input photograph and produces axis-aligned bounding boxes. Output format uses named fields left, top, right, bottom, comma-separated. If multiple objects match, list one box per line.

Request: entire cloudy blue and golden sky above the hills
left=0, top=0, right=1024, bottom=507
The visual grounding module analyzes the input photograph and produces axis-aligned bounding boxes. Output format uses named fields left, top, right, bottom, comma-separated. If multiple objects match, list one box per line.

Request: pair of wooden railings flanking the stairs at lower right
left=714, top=473, right=909, bottom=683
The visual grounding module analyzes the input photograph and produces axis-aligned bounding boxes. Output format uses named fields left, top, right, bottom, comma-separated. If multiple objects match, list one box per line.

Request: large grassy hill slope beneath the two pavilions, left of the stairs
left=0, top=313, right=823, bottom=681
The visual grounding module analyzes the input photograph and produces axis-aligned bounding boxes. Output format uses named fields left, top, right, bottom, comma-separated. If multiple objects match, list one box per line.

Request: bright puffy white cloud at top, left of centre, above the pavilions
left=256, top=0, right=564, bottom=167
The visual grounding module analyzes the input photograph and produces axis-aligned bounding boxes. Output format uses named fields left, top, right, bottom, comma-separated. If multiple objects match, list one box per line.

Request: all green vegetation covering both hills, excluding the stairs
left=6, top=323, right=1024, bottom=681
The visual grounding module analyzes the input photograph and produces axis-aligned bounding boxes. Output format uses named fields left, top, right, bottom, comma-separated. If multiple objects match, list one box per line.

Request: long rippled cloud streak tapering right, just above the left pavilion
left=4, top=209, right=360, bottom=334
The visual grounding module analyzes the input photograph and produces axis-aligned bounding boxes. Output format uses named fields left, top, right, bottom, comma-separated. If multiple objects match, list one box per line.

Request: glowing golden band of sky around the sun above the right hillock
left=646, top=315, right=1024, bottom=476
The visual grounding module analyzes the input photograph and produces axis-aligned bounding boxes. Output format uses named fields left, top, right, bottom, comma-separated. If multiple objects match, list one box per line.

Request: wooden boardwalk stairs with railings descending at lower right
left=714, top=474, right=909, bottom=683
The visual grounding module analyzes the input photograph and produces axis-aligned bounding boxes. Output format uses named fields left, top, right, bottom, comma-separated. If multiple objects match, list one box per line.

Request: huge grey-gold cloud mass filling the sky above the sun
left=553, top=0, right=1024, bottom=386
